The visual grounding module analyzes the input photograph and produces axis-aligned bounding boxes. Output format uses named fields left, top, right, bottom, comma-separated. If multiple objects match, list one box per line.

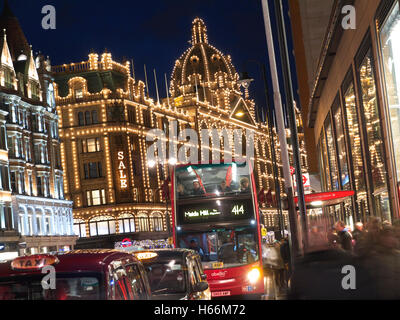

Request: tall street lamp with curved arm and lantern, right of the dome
left=238, top=60, right=285, bottom=236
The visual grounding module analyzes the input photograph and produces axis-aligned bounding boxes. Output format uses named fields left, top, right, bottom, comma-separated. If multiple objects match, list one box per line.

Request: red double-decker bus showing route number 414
left=172, top=163, right=264, bottom=298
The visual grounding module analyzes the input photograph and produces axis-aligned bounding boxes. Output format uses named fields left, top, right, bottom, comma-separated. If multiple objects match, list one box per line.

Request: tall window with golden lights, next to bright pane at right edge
left=359, top=53, right=390, bottom=221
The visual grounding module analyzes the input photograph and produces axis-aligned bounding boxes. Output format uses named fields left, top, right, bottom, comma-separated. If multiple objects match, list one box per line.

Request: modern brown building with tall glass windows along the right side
left=292, top=0, right=400, bottom=224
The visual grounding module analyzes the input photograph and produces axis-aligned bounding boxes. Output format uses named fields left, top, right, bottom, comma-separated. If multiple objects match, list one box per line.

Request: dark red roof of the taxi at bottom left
left=0, top=249, right=139, bottom=277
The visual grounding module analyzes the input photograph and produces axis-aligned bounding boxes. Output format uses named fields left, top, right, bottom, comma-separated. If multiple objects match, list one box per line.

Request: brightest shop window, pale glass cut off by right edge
left=380, top=2, right=400, bottom=181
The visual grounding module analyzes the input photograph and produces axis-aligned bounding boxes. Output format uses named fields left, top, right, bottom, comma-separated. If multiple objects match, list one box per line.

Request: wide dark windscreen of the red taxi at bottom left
left=0, top=273, right=104, bottom=300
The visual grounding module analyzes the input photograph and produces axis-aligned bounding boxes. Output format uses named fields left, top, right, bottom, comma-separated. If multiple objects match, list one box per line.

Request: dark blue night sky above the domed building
left=9, top=0, right=276, bottom=105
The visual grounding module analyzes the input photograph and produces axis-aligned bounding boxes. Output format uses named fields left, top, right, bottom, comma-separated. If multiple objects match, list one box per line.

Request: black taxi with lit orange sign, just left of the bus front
left=134, top=249, right=211, bottom=300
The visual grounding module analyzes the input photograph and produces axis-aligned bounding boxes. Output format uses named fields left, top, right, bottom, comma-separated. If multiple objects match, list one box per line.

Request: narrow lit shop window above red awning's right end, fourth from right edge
left=333, top=105, right=350, bottom=190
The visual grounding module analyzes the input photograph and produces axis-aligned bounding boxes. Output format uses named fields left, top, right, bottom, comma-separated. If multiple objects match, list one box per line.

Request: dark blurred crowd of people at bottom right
left=289, top=218, right=400, bottom=300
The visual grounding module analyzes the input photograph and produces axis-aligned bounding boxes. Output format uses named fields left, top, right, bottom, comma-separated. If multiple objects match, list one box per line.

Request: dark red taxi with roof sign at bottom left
left=0, top=250, right=151, bottom=300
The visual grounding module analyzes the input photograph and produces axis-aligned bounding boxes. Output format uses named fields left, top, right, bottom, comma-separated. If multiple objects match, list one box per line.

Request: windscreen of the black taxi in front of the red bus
left=144, top=257, right=187, bottom=295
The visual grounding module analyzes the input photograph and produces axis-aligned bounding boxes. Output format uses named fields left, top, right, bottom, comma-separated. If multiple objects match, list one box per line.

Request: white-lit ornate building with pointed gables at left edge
left=0, top=1, right=76, bottom=255
